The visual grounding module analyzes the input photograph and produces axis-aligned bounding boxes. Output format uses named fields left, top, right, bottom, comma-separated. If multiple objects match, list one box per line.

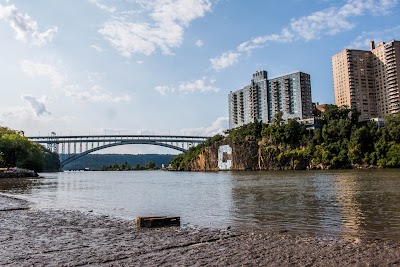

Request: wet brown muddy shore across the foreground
left=0, top=195, right=400, bottom=266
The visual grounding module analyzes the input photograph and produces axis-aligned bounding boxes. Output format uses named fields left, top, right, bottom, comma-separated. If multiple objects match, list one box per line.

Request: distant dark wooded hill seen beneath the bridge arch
left=60, top=154, right=176, bottom=170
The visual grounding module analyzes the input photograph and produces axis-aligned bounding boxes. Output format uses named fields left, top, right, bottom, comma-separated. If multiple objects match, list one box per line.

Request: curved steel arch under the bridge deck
left=61, top=140, right=187, bottom=169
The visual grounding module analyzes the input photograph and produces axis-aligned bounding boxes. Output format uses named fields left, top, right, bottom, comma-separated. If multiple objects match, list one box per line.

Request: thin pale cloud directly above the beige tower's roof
left=347, top=25, right=400, bottom=49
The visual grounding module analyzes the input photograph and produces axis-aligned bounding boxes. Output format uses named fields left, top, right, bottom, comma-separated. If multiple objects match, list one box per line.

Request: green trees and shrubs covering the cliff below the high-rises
left=171, top=105, right=400, bottom=170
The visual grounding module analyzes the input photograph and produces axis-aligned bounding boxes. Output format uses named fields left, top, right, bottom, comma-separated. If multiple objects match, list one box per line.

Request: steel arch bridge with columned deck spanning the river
left=28, top=133, right=209, bottom=168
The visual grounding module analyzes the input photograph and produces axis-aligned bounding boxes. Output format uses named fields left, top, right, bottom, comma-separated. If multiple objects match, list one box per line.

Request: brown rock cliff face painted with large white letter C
left=189, top=138, right=306, bottom=171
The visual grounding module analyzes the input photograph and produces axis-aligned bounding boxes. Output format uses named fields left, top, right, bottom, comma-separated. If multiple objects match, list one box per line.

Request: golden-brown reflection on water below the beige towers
left=337, top=170, right=400, bottom=241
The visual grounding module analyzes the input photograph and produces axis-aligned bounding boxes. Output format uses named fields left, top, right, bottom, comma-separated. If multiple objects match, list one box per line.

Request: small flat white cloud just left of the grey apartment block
left=154, top=77, right=220, bottom=95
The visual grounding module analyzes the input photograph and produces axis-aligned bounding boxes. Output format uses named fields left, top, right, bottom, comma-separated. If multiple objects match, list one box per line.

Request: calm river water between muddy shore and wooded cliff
left=0, top=170, right=400, bottom=240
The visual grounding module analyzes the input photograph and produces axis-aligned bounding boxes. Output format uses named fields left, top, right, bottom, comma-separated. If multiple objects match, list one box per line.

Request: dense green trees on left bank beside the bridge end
left=0, top=127, right=60, bottom=172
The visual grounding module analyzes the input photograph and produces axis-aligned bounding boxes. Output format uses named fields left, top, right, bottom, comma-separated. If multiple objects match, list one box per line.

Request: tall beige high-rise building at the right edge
left=332, top=41, right=400, bottom=120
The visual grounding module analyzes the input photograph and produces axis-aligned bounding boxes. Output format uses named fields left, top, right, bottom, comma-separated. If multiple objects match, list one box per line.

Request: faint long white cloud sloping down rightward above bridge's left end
left=21, top=60, right=131, bottom=102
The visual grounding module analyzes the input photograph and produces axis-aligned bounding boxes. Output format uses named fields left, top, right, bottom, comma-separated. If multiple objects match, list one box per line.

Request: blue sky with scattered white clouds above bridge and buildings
left=0, top=0, right=400, bottom=153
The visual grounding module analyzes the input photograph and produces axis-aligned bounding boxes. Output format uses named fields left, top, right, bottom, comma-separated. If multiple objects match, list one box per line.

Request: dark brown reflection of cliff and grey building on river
left=232, top=171, right=341, bottom=237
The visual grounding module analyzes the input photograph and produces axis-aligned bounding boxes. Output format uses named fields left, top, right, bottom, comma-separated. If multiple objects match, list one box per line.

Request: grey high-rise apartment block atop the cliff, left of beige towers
left=229, top=71, right=312, bottom=128
